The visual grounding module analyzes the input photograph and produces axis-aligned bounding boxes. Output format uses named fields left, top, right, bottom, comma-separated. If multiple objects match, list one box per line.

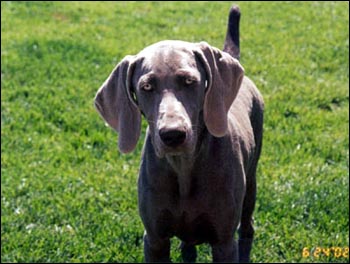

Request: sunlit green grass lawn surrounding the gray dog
left=1, top=2, right=349, bottom=262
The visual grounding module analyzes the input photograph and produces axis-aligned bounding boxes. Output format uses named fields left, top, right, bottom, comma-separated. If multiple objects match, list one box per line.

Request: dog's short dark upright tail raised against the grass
left=224, top=5, right=241, bottom=60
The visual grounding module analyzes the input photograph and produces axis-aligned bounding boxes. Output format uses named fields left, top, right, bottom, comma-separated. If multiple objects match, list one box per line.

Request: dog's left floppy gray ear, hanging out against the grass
left=95, top=56, right=141, bottom=153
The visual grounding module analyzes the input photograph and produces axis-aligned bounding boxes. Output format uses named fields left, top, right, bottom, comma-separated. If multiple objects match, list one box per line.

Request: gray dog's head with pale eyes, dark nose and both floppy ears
left=95, top=41, right=244, bottom=157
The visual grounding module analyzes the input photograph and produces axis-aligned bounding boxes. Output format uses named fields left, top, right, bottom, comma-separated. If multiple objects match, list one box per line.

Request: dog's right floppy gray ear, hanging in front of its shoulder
left=194, top=42, right=244, bottom=137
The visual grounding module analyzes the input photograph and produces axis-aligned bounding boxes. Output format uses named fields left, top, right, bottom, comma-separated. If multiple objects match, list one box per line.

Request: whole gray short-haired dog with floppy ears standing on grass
left=95, top=7, right=264, bottom=262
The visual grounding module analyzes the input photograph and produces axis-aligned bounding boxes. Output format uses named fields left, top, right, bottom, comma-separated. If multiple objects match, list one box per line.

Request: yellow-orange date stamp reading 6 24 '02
left=302, top=247, right=349, bottom=258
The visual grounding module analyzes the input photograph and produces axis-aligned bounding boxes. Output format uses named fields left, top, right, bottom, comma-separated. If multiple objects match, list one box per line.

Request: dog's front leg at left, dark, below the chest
left=143, top=233, right=171, bottom=263
